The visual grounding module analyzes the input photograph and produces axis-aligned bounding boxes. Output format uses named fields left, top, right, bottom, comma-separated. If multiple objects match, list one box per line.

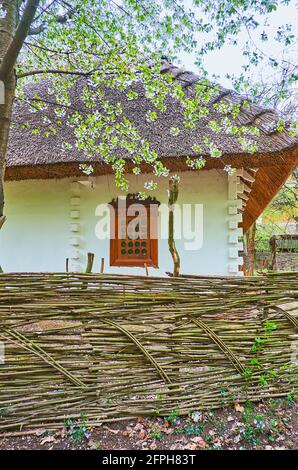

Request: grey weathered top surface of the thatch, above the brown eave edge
left=7, top=64, right=298, bottom=171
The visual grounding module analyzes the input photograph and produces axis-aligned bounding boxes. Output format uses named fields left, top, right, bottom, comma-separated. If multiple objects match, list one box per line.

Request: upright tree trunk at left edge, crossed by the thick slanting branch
left=0, top=0, right=19, bottom=224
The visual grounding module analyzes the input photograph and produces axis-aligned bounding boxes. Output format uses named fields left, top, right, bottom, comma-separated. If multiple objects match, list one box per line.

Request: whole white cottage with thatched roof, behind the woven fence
left=0, top=64, right=298, bottom=276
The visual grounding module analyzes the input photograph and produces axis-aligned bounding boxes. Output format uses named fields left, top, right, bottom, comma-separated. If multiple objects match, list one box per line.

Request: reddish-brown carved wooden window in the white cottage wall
left=110, top=195, right=159, bottom=268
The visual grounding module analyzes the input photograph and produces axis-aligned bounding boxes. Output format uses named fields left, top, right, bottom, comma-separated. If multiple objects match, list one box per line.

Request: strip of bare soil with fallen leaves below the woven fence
left=0, top=396, right=298, bottom=450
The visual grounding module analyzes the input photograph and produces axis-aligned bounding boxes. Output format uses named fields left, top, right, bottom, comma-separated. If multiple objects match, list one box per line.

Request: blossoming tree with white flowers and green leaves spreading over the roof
left=0, top=0, right=295, bottom=235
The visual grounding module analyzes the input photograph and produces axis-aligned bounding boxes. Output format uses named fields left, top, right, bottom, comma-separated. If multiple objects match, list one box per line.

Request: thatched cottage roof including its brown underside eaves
left=6, top=63, right=298, bottom=228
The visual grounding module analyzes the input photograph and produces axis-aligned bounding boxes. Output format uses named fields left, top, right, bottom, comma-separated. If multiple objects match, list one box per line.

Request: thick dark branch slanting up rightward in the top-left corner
left=0, top=0, right=40, bottom=81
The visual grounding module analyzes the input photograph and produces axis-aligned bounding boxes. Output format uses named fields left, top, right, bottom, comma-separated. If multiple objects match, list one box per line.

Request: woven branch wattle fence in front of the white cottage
left=0, top=273, right=298, bottom=431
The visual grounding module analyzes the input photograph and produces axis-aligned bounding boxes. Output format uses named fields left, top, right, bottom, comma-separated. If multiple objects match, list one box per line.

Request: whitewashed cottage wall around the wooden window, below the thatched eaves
left=0, top=170, right=240, bottom=275
